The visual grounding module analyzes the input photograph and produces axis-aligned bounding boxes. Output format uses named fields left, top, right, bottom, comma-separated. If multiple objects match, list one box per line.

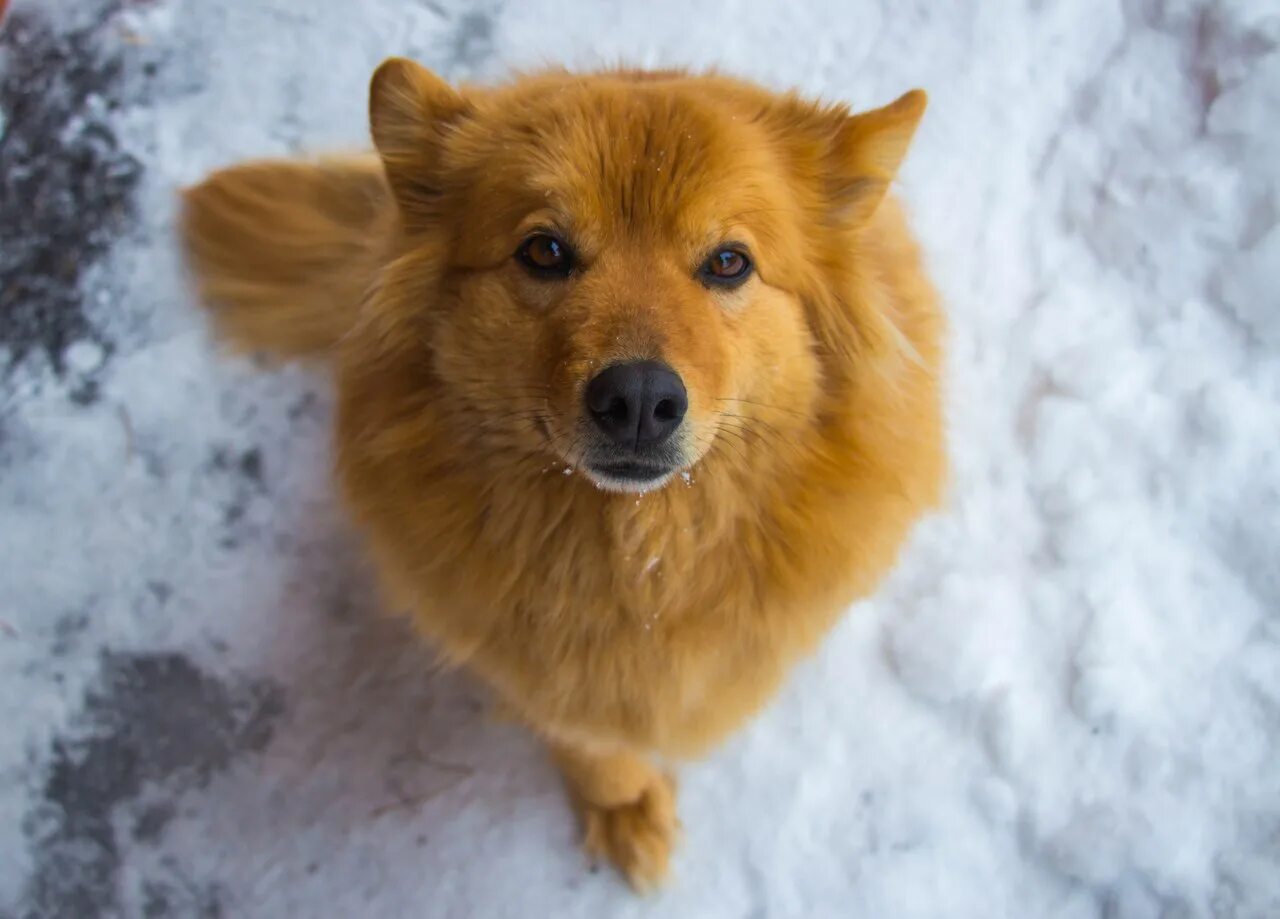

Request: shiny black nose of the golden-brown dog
left=586, top=361, right=689, bottom=449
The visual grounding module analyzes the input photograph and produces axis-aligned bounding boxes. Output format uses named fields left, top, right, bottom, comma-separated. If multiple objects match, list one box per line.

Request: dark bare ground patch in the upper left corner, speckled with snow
left=0, top=0, right=142, bottom=376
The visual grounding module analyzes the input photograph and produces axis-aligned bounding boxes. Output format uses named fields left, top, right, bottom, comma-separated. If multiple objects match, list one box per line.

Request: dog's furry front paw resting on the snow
left=582, top=776, right=680, bottom=893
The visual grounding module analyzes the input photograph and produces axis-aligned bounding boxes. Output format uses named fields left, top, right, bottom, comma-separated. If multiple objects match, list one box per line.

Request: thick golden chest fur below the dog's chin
left=348, top=435, right=847, bottom=754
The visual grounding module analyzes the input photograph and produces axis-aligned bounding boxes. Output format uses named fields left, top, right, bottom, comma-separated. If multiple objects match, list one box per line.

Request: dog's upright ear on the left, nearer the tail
left=369, top=58, right=470, bottom=218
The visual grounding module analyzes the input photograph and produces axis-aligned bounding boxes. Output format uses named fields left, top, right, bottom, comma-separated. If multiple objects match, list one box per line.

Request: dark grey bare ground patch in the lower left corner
left=20, top=653, right=283, bottom=919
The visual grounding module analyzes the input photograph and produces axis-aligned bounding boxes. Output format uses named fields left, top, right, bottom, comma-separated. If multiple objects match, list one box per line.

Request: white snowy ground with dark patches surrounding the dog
left=0, top=0, right=1280, bottom=919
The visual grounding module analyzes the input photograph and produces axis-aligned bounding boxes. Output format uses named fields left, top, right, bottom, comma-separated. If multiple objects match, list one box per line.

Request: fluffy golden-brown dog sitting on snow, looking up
left=182, top=59, right=946, bottom=890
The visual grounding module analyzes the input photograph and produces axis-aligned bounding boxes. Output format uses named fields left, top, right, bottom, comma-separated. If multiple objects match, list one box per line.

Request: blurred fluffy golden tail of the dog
left=182, top=156, right=393, bottom=358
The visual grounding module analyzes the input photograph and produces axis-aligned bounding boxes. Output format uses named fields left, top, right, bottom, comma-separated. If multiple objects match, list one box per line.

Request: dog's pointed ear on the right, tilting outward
left=828, top=90, right=928, bottom=224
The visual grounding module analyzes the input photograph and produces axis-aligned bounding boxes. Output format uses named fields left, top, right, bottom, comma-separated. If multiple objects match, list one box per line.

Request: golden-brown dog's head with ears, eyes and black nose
left=370, top=59, right=924, bottom=491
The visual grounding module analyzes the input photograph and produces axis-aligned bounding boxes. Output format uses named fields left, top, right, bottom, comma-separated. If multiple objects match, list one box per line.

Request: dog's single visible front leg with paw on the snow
left=552, top=744, right=680, bottom=891
